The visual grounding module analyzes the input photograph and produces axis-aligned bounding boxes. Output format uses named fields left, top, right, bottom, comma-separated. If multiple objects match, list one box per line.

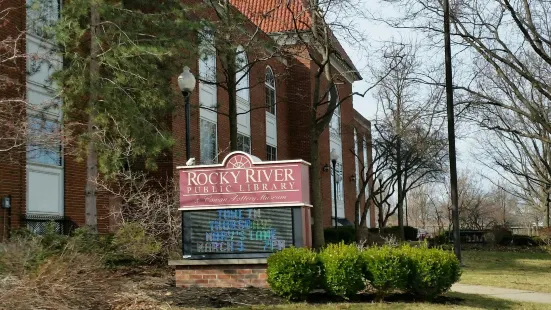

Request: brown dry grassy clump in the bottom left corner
left=0, top=253, right=118, bottom=310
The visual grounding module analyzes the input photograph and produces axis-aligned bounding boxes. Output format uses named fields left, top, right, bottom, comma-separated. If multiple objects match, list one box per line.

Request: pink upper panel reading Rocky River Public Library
left=178, top=152, right=310, bottom=210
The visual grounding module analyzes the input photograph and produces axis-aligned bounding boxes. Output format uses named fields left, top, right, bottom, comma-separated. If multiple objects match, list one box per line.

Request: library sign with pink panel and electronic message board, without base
left=178, top=152, right=311, bottom=259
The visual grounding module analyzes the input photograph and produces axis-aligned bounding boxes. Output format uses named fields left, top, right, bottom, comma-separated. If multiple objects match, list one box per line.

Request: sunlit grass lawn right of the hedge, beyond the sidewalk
left=460, top=251, right=551, bottom=293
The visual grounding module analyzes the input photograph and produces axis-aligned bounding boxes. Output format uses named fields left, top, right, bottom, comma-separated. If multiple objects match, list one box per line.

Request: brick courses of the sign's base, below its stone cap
left=175, top=264, right=268, bottom=288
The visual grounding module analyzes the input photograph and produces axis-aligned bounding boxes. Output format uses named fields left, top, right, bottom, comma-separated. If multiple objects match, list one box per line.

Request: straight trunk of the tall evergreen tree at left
left=85, top=1, right=100, bottom=233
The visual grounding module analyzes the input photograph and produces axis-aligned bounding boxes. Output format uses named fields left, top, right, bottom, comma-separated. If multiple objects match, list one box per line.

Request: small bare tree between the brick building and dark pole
left=373, top=44, right=447, bottom=238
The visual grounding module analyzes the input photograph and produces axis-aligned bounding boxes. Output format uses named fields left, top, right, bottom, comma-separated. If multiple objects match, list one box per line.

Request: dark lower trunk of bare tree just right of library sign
left=310, top=134, right=325, bottom=249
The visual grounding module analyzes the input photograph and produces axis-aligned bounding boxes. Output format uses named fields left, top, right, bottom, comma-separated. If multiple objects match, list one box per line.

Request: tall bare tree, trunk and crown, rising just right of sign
left=266, top=0, right=390, bottom=247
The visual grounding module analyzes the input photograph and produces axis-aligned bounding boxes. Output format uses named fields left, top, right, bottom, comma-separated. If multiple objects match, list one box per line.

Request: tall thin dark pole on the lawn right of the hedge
left=444, top=0, right=461, bottom=263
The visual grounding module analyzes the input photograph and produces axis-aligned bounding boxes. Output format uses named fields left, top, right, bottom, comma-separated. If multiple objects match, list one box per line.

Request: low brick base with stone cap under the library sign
left=169, top=259, right=268, bottom=288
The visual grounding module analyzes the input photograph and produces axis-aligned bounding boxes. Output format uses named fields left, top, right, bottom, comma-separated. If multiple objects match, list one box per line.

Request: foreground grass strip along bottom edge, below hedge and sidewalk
left=226, top=293, right=549, bottom=310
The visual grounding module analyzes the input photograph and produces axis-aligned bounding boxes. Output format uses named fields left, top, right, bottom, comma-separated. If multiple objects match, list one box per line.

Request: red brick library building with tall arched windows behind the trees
left=0, top=0, right=375, bottom=240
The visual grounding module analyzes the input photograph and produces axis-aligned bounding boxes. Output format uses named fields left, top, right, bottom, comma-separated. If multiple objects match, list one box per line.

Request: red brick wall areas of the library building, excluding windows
left=0, top=0, right=374, bottom=236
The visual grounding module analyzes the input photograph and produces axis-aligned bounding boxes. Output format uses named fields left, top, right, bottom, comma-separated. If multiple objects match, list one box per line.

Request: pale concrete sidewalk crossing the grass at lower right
left=451, top=284, right=551, bottom=304
